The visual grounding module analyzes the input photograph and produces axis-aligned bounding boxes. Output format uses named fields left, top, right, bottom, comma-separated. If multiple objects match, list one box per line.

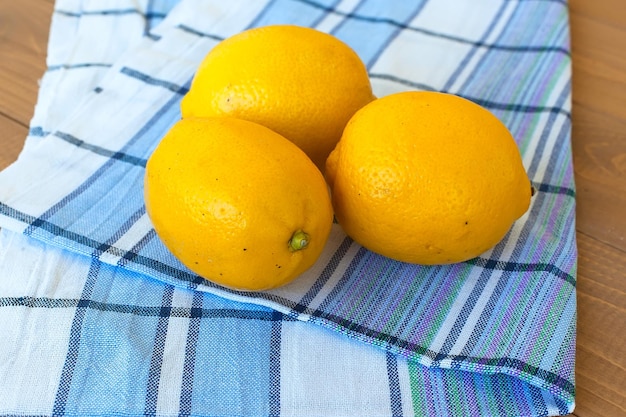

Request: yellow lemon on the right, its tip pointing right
left=326, top=92, right=532, bottom=264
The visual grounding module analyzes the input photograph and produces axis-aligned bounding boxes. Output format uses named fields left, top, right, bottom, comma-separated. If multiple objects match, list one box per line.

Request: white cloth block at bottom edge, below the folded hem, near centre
left=280, top=322, right=391, bottom=417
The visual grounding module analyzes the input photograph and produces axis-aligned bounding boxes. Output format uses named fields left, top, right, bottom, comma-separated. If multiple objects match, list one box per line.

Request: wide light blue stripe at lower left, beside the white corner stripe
left=60, top=272, right=176, bottom=415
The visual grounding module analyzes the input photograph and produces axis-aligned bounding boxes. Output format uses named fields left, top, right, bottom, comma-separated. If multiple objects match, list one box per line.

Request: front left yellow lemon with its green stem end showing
left=144, top=117, right=332, bottom=290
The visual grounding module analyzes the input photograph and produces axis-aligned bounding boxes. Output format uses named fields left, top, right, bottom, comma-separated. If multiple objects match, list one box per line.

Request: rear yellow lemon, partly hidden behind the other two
left=181, top=25, right=374, bottom=169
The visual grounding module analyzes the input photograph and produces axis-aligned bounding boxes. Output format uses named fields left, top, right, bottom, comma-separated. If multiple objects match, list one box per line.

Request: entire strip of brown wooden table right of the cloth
left=569, top=0, right=626, bottom=417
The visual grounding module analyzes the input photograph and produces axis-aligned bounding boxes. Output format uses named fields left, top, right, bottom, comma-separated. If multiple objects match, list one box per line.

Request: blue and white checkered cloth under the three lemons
left=0, top=0, right=576, bottom=417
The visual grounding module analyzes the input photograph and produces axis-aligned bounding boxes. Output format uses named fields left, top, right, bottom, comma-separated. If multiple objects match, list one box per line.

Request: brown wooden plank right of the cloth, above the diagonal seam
left=570, top=0, right=626, bottom=258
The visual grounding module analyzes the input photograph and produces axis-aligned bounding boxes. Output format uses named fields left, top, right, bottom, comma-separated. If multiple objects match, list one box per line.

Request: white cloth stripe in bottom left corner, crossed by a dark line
left=0, top=229, right=85, bottom=415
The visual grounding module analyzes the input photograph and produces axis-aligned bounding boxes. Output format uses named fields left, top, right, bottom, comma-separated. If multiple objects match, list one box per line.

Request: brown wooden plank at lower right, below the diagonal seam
left=575, top=234, right=626, bottom=416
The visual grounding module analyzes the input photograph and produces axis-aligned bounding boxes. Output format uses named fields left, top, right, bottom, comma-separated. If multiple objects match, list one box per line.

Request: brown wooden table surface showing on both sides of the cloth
left=0, top=0, right=626, bottom=417
